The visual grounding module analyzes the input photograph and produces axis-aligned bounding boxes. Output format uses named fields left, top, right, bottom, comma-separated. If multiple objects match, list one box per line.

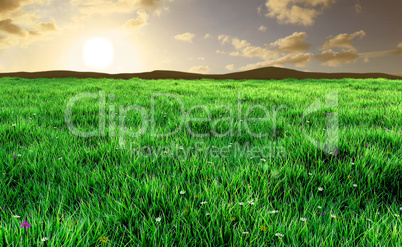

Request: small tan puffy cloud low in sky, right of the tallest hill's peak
left=315, top=49, right=359, bottom=67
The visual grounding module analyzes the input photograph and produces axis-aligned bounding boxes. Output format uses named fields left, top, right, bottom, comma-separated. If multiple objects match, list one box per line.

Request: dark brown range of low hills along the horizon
left=0, top=67, right=402, bottom=80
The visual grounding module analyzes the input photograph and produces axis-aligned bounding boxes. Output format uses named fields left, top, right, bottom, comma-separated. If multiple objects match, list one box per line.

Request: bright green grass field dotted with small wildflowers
left=0, top=78, right=402, bottom=246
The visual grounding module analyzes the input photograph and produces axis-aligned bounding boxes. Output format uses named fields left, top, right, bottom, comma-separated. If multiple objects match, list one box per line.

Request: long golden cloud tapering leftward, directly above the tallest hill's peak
left=239, top=53, right=314, bottom=70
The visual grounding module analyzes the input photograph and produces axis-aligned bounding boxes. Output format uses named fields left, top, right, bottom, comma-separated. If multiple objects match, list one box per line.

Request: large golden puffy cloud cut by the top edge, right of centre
left=265, top=0, right=336, bottom=26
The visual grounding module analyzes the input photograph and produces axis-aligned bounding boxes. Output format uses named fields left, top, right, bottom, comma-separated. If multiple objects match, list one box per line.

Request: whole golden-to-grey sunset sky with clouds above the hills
left=0, top=0, right=402, bottom=74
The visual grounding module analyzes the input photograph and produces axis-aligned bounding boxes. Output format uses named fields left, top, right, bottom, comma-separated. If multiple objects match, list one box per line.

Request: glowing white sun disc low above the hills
left=83, top=38, right=114, bottom=69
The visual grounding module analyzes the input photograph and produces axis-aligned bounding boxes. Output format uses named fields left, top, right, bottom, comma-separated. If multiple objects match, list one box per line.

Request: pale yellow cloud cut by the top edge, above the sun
left=70, top=0, right=167, bottom=15
